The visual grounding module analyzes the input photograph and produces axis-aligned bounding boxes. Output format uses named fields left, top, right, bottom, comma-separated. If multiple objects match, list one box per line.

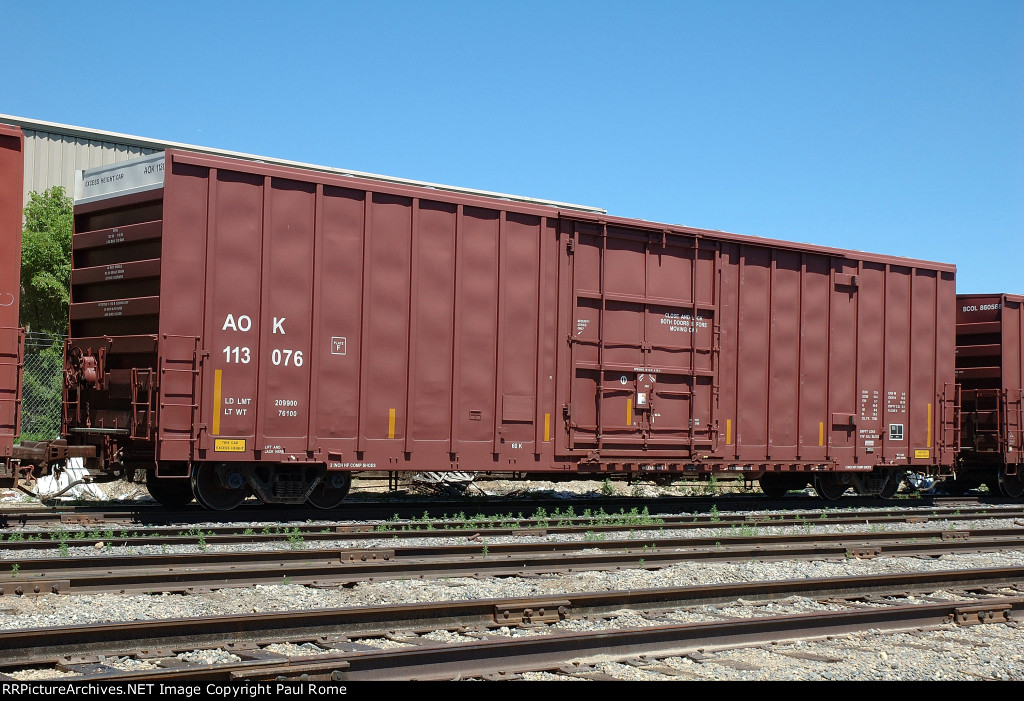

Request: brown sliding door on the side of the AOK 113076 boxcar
left=562, top=219, right=719, bottom=462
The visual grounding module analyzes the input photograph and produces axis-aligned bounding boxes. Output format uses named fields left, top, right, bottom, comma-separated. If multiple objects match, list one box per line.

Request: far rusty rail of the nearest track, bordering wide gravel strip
left=0, top=567, right=1024, bottom=670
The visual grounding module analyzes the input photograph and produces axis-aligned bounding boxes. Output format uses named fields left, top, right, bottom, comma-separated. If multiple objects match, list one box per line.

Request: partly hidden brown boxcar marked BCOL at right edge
left=949, top=295, right=1024, bottom=497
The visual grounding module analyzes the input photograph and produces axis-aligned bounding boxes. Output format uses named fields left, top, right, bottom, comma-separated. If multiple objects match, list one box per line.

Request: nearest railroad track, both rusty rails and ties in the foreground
left=0, top=568, right=1024, bottom=682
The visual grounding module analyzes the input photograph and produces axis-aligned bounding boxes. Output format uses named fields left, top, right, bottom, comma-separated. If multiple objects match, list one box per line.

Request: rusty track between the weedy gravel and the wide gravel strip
left=0, top=528, right=1024, bottom=596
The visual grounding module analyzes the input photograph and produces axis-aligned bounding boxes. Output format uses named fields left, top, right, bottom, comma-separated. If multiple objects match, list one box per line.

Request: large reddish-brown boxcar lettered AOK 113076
left=66, top=150, right=955, bottom=508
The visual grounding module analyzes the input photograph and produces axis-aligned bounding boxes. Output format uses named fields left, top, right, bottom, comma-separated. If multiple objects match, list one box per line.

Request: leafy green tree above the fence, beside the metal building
left=20, top=185, right=74, bottom=335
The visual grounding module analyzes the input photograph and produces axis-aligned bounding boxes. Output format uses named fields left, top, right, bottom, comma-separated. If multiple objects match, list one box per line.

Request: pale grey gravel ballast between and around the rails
left=0, top=487, right=1024, bottom=681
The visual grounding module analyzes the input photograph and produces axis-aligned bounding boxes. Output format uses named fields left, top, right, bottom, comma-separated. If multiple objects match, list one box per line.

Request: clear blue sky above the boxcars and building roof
left=0, top=0, right=1024, bottom=294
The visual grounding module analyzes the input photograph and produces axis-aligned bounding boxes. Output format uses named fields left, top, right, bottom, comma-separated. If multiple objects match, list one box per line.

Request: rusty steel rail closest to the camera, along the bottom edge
left=4, top=598, right=1024, bottom=683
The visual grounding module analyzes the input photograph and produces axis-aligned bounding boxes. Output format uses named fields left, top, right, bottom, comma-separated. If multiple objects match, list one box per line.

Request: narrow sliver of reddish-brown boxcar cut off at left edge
left=0, top=124, right=25, bottom=464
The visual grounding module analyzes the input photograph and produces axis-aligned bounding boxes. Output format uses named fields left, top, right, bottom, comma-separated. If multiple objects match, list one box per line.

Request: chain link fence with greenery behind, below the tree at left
left=22, top=332, right=63, bottom=441
